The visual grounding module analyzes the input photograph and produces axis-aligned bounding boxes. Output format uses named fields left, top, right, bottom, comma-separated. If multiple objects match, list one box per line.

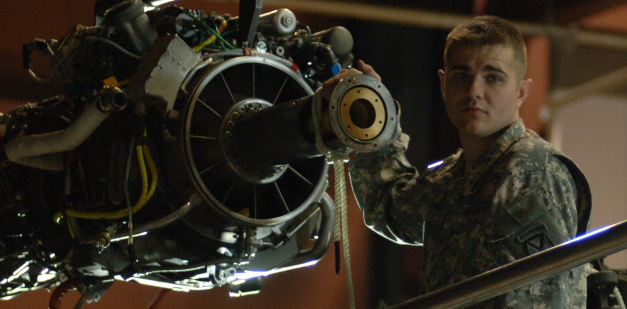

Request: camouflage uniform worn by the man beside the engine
left=350, top=120, right=590, bottom=309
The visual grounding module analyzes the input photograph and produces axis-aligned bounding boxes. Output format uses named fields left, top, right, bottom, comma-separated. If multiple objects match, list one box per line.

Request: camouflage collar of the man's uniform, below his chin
left=458, top=119, right=526, bottom=194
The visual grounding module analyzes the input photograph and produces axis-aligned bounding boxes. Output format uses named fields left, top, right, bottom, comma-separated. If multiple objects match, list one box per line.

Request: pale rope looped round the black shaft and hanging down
left=311, top=88, right=355, bottom=309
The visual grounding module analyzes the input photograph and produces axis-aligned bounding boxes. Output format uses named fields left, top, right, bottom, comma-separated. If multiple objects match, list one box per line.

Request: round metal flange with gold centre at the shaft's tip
left=329, top=74, right=398, bottom=152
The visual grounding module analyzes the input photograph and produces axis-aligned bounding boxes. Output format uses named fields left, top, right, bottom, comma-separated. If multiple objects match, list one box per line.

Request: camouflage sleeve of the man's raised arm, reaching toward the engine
left=349, top=134, right=424, bottom=245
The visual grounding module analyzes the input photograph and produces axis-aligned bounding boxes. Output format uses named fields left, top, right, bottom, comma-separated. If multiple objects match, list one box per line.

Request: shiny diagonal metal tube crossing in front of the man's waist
left=390, top=221, right=627, bottom=309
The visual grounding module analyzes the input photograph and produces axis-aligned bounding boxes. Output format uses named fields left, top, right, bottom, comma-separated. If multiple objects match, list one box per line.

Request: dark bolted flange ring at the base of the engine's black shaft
left=220, top=98, right=289, bottom=184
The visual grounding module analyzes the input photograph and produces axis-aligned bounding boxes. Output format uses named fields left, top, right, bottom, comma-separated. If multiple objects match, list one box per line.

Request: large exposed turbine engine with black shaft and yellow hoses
left=0, top=0, right=398, bottom=308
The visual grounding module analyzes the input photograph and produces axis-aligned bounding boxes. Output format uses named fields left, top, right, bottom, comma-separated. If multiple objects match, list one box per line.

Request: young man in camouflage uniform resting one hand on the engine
left=322, top=16, right=590, bottom=309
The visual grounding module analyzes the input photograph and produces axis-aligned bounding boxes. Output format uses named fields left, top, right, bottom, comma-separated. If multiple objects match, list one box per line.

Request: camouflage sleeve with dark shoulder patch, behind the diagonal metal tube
left=503, top=157, right=586, bottom=309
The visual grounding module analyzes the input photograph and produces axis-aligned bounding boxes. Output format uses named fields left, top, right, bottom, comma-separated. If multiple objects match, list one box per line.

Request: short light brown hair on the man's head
left=444, top=15, right=527, bottom=80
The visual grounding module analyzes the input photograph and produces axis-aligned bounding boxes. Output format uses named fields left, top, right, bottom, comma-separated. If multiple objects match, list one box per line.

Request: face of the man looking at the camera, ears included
left=439, top=45, right=531, bottom=141
